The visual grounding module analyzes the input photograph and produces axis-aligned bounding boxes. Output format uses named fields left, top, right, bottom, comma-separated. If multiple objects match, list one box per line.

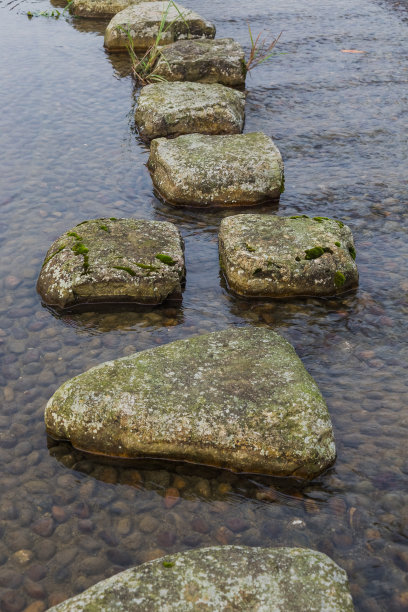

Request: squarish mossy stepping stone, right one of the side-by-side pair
left=219, top=215, right=358, bottom=297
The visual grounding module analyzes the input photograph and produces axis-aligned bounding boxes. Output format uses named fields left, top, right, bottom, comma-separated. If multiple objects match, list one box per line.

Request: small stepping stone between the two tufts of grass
left=154, top=38, right=246, bottom=87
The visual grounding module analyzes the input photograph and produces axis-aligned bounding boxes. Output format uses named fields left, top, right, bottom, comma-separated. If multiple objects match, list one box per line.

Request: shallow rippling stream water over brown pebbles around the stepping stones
left=0, top=0, right=408, bottom=612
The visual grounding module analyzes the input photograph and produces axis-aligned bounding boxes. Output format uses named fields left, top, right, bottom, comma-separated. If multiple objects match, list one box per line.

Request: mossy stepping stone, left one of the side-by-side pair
left=37, top=217, right=185, bottom=308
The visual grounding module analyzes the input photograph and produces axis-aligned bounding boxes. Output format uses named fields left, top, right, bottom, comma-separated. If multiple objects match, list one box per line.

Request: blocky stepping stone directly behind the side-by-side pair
left=148, top=132, right=283, bottom=207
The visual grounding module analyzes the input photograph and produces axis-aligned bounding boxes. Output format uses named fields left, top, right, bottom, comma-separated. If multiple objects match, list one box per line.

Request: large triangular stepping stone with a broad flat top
left=45, top=328, right=335, bottom=478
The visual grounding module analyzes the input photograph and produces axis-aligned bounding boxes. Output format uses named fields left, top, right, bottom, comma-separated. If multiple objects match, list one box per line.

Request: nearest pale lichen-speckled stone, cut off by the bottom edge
left=50, top=546, right=354, bottom=612
